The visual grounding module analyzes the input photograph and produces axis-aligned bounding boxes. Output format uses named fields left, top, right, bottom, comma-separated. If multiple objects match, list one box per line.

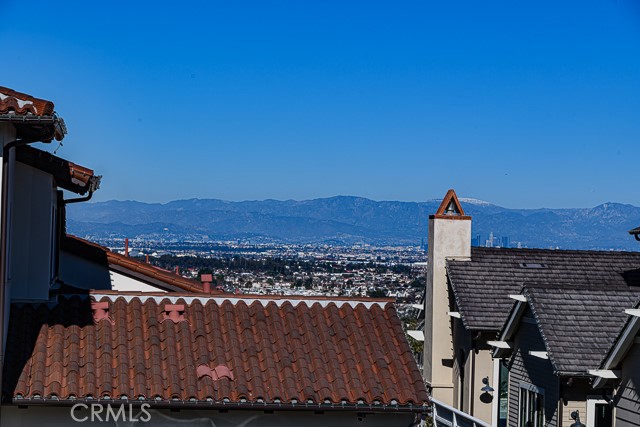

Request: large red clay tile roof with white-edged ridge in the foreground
left=3, top=293, right=428, bottom=412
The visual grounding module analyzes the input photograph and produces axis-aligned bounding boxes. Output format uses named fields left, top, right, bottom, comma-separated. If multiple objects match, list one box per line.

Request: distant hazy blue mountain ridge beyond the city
left=67, top=196, right=640, bottom=251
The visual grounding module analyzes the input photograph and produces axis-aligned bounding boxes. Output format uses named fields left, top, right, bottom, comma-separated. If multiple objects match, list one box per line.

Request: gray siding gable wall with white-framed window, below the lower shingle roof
left=508, top=310, right=559, bottom=427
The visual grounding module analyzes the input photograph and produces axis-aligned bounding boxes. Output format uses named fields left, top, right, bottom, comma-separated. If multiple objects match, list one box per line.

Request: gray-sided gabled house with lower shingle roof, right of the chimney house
left=495, top=284, right=640, bottom=427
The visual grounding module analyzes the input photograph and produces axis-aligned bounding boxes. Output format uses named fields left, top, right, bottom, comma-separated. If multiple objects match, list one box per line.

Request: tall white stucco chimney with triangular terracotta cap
left=424, top=190, right=471, bottom=405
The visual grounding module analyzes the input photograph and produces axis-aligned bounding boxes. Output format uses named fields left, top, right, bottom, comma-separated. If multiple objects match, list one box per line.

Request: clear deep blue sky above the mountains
left=0, top=0, right=640, bottom=207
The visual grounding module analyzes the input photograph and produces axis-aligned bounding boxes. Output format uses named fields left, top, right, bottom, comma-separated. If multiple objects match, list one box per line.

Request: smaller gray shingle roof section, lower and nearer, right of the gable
left=523, top=284, right=640, bottom=373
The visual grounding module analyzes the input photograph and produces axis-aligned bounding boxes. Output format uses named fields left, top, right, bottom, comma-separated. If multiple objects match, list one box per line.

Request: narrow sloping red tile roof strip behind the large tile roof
left=61, top=234, right=214, bottom=293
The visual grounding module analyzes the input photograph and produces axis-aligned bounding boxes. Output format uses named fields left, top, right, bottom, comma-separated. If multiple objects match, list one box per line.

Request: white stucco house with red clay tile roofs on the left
left=0, top=87, right=429, bottom=427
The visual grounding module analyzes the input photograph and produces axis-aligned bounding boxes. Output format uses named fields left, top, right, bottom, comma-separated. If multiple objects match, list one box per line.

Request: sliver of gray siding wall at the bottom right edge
left=614, top=343, right=640, bottom=427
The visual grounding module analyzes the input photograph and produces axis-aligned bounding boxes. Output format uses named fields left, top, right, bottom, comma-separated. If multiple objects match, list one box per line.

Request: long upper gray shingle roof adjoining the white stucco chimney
left=447, top=247, right=640, bottom=331
